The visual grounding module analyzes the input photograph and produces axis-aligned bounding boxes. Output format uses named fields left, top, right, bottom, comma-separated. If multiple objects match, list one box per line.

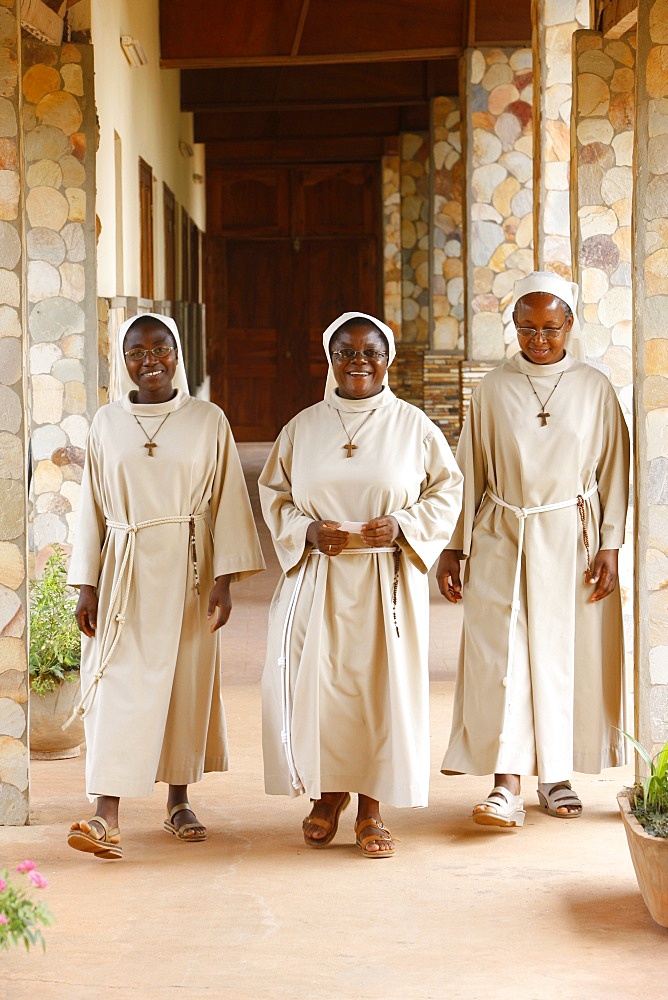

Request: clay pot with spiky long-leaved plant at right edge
left=617, top=733, right=668, bottom=927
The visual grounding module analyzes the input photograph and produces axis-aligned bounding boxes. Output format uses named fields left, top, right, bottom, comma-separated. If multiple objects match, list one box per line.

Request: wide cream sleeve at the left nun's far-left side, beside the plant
left=67, top=420, right=106, bottom=587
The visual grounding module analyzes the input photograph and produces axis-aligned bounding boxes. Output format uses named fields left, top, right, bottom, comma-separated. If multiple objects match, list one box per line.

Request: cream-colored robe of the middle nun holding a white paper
left=260, top=387, right=462, bottom=806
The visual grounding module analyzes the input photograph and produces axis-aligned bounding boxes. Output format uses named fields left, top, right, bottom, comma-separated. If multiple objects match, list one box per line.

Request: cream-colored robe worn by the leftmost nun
left=69, top=391, right=264, bottom=796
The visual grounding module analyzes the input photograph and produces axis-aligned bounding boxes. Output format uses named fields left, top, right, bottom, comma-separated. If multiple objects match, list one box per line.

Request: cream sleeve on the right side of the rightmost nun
left=596, top=386, right=629, bottom=549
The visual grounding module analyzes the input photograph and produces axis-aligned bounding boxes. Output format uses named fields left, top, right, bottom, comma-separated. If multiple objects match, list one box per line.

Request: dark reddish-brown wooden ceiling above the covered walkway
left=160, top=0, right=531, bottom=163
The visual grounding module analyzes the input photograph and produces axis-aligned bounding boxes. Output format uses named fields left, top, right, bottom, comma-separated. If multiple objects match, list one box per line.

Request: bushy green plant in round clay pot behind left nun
left=30, top=545, right=84, bottom=760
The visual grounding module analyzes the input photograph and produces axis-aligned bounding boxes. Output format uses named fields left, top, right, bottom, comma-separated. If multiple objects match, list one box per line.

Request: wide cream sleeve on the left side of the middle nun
left=258, top=425, right=313, bottom=573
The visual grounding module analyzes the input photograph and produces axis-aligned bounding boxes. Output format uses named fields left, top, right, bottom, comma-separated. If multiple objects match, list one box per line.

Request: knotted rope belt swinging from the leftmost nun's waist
left=62, top=513, right=206, bottom=729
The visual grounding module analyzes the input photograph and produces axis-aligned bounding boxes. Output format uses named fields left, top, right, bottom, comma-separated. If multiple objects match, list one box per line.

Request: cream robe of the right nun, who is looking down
left=443, top=354, right=629, bottom=781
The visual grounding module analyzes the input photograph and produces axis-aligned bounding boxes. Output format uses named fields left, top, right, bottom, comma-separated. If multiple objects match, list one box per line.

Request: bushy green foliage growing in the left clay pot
left=30, top=545, right=81, bottom=694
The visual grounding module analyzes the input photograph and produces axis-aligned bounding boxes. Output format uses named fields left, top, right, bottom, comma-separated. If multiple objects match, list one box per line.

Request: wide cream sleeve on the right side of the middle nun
left=392, top=427, right=463, bottom=573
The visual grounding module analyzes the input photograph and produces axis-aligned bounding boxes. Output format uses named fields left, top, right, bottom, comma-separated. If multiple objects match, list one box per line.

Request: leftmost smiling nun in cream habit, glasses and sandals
left=68, top=313, right=264, bottom=857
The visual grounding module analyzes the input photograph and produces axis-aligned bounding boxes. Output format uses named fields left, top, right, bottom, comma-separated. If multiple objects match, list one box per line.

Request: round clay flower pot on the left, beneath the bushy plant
left=30, top=677, right=84, bottom=760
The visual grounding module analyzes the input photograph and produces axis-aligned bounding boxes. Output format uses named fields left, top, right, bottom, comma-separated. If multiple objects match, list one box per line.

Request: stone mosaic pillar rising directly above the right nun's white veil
left=532, top=0, right=590, bottom=281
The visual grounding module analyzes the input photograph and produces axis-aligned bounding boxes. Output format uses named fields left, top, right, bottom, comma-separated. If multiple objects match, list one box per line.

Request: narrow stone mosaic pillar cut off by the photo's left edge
left=0, top=0, right=29, bottom=826
